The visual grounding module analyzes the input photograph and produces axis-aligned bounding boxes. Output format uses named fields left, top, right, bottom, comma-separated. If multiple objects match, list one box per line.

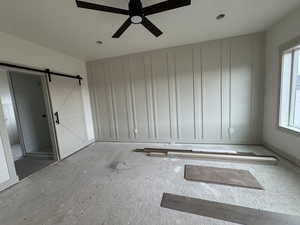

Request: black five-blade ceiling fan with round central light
left=76, top=0, right=191, bottom=38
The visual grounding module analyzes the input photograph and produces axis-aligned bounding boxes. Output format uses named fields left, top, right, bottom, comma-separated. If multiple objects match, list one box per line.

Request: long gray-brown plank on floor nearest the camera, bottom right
left=161, top=193, right=300, bottom=225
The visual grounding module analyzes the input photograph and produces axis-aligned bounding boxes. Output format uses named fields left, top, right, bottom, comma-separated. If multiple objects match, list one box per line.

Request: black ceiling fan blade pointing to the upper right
left=143, top=0, right=191, bottom=16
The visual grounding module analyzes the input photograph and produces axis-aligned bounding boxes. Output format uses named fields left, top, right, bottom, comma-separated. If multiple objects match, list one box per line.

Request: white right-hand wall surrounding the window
left=263, top=8, right=300, bottom=161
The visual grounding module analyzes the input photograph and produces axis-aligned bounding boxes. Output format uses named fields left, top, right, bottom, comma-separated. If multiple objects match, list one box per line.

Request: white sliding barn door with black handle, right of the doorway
left=49, top=76, right=88, bottom=159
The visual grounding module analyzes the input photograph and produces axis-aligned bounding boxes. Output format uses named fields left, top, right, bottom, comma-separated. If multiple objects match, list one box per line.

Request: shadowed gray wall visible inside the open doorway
left=10, top=72, right=52, bottom=153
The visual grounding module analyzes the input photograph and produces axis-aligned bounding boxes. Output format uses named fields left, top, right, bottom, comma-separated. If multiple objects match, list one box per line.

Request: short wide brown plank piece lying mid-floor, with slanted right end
left=184, top=165, right=263, bottom=190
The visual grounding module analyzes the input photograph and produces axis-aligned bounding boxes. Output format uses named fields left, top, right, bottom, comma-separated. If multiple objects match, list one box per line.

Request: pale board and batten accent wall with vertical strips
left=87, top=33, right=265, bottom=144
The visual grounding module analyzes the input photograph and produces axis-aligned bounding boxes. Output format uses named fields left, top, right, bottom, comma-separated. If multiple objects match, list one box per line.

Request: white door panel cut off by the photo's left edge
left=0, top=99, right=18, bottom=191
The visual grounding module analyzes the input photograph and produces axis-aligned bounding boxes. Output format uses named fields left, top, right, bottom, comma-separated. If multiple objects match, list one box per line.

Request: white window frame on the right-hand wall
left=277, top=37, right=300, bottom=136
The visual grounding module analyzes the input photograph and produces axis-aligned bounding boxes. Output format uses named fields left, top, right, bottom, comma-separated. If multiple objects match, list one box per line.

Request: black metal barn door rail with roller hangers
left=0, top=62, right=83, bottom=85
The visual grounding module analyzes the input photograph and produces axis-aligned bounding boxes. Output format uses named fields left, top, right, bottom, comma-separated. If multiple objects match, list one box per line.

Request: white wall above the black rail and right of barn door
left=0, top=32, right=94, bottom=140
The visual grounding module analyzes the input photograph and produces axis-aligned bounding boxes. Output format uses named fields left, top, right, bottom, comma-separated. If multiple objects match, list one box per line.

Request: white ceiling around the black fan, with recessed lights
left=0, top=0, right=300, bottom=60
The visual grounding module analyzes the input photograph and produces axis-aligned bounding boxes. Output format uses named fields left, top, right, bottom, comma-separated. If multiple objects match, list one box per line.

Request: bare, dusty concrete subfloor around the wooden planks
left=0, top=143, right=300, bottom=225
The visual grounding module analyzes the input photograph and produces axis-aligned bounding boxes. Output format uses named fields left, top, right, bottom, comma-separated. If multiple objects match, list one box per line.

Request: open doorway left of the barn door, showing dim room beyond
left=0, top=71, right=58, bottom=180
